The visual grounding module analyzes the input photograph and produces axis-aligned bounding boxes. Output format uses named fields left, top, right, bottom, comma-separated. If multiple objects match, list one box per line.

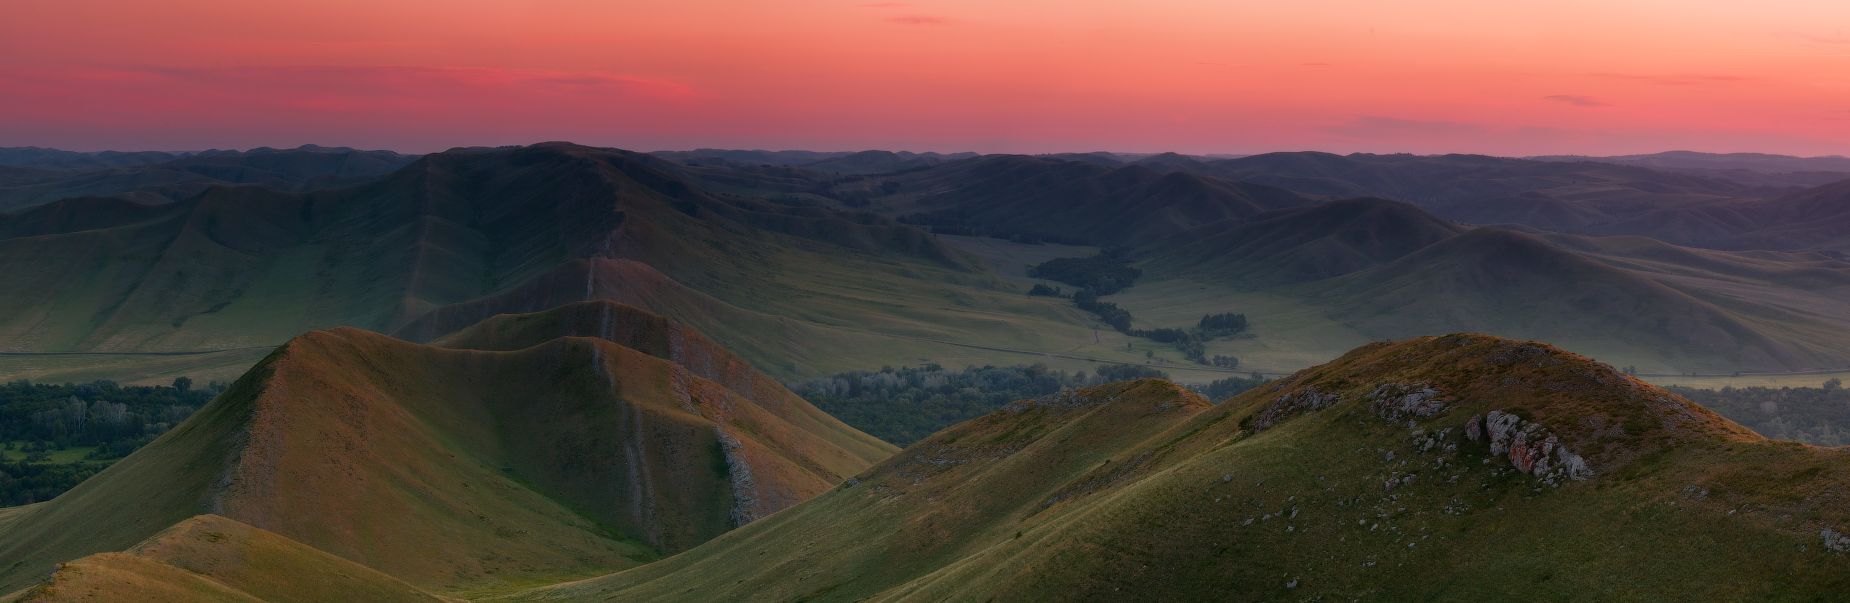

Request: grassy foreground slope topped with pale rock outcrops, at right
left=516, top=335, right=1850, bottom=601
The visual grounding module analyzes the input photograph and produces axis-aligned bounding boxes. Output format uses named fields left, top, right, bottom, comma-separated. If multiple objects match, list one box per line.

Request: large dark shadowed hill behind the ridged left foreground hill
left=0, top=144, right=966, bottom=351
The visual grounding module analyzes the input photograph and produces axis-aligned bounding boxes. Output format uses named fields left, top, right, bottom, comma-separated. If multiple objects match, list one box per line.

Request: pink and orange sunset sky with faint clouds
left=0, top=0, right=1850, bottom=155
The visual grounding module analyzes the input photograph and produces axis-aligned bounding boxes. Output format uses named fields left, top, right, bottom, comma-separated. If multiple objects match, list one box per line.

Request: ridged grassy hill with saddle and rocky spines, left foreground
left=0, top=314, right=892, bottom=592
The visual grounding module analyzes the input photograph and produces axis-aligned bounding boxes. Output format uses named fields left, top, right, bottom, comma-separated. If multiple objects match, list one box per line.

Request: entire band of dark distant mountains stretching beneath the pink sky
left=0, top=142, right=1850, bottom=377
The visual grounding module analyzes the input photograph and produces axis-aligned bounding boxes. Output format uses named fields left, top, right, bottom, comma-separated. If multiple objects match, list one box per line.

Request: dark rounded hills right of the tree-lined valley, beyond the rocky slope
left=1130, top=200, right=1850, bottom=374
